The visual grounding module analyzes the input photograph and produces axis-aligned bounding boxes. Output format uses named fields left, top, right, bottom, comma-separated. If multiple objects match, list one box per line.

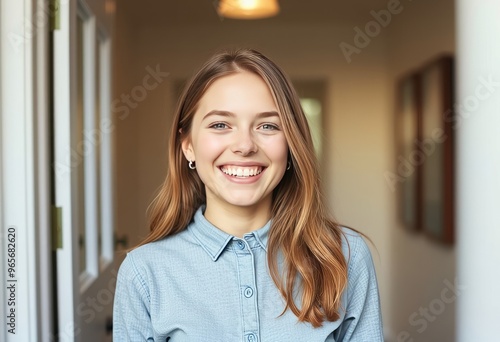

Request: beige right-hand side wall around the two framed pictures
left=387, top=0, right=456, bottom=342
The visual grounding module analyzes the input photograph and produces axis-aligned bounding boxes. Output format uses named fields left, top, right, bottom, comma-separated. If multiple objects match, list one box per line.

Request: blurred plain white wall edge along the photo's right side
left=456, top=0, right=500, bottom=342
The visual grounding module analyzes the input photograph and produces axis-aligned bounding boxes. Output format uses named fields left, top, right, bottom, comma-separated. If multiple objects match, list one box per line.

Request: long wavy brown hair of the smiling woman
left=140, top=49, right=347, bottom=327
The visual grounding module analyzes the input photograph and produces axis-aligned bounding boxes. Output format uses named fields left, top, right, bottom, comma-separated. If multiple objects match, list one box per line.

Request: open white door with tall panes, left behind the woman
left=52, top=0, right=116, bottom=342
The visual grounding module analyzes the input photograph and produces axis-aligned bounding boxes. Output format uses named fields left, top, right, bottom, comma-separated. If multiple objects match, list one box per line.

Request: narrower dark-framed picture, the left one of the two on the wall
left=396, top=73, right=422, bottom=231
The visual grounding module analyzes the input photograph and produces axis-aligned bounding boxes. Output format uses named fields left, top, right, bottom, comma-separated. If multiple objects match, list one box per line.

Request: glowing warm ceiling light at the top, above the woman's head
left=218, top=0, right=280, bottom=19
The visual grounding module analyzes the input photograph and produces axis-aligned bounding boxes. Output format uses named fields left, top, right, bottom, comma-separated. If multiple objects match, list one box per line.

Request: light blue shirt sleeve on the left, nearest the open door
left=113, top=254, right=154, bottom=342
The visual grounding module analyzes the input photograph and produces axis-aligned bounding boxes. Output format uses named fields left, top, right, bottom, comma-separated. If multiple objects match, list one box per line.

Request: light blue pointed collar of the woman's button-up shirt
left=188, top=205, right=271, bottom=261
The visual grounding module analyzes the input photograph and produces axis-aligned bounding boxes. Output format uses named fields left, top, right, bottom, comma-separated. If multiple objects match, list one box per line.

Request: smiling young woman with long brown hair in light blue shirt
left=113, top=50, right=383, bottom=342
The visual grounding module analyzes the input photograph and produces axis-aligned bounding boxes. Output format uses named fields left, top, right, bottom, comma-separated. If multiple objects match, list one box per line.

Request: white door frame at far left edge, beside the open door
left=0, top=0, right=54, bottom=342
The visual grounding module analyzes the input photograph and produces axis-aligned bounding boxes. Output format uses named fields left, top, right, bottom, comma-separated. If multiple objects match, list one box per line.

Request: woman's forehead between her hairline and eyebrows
left=197, top=71, right=277, bottom=118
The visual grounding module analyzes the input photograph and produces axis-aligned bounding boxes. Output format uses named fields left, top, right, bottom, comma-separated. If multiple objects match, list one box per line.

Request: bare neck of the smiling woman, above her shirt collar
left=204, top=201, right=271, bottom=238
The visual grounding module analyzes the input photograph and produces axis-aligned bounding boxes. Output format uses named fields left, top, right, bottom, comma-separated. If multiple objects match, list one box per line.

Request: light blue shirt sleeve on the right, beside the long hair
left=334, top=233, right=384, bottom=342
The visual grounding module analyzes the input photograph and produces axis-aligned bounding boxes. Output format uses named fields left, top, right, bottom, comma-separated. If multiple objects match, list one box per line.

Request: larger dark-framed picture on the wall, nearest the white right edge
left=419, top=56, right=454, bottom=244
